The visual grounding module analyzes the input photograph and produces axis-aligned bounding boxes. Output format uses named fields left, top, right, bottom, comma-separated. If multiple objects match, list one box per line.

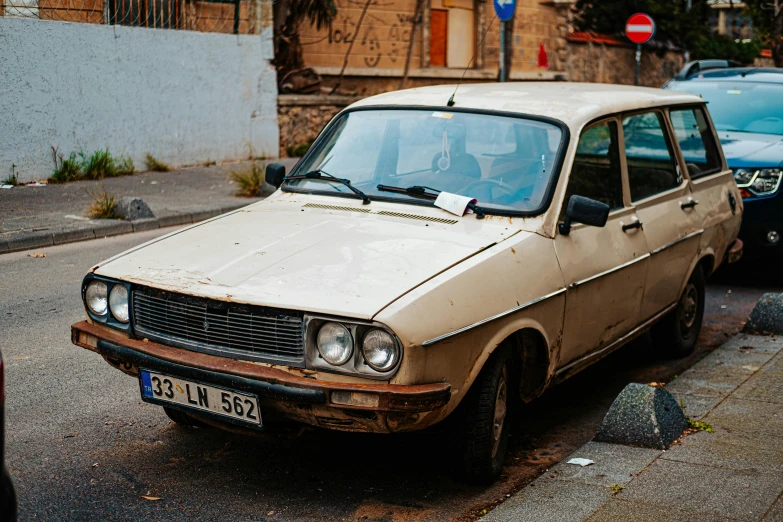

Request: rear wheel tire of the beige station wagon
left=651, top=265, right=705, bottom=357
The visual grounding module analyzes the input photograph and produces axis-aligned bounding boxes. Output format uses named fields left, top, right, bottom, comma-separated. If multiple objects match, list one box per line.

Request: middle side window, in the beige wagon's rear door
left=623, top=112, right=682, bottom=201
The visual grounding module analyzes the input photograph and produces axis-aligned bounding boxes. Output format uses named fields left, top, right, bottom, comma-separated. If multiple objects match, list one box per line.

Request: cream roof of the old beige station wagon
left=348, top=82, right=704, bottom=130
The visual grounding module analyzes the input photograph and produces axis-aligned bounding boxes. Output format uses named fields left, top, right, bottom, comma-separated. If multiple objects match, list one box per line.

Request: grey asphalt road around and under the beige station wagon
left=0, top=231, right=780, bottom=521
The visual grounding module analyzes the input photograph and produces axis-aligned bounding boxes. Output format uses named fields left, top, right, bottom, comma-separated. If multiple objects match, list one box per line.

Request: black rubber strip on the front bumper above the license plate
left=98, top=339, right=326, bottom=404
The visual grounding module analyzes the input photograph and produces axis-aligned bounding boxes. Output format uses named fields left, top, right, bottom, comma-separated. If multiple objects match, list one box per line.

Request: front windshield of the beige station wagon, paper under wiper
left=288, top=109, right=564, bottom=213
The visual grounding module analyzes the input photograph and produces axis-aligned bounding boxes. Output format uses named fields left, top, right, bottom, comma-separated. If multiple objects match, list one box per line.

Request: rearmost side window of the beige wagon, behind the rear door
left=669, top=108, right=722, bottom=179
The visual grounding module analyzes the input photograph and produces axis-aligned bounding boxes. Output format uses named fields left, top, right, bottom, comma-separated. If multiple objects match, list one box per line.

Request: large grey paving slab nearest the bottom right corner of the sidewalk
left=617, top=458, right=783, bottom=520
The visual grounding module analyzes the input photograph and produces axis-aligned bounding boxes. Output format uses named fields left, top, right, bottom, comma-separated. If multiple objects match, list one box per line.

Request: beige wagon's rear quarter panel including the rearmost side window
left=669, top=106, right=742, bottom=268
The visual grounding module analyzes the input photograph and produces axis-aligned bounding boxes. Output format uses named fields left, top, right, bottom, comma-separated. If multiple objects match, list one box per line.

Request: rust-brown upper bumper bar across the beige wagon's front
left=71, top=321, right=451, bottom=413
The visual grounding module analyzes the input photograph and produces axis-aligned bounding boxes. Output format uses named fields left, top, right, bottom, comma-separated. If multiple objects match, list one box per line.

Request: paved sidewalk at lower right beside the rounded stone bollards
left=482, top=334, right=783, bottom=522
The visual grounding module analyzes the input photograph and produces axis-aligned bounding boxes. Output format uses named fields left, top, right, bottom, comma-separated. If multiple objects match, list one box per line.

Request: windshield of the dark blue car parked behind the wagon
left=670, top=81, right=783, bottom=135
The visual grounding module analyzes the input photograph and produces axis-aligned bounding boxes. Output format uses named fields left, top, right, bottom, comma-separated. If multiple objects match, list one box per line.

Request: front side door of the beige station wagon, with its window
left=555, top=118, right=649, bottom=366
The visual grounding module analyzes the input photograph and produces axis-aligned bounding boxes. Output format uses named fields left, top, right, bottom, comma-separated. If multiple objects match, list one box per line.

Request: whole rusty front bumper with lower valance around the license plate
left=71, top=321, right=451, bottom=432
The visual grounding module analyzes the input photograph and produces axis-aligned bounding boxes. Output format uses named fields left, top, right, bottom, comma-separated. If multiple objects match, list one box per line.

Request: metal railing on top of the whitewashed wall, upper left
left=0, top=0, right=271, bottom=34
